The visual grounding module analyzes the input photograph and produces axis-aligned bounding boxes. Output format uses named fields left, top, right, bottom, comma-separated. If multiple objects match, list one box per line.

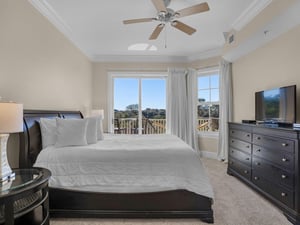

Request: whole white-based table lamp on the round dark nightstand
left=0, top=101, right=23, bottom=185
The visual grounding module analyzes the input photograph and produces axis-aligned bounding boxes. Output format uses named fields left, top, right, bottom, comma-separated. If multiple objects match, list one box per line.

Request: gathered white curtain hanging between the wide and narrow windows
left=167, top=68, right=198, bottom=150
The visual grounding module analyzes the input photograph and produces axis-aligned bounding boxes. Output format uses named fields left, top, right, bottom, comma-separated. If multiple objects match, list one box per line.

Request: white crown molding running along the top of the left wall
left=29, top=0, right=91, bottom=59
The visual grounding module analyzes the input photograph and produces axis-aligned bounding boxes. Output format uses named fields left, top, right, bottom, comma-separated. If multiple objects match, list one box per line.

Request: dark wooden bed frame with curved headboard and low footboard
left=19, top=110, right=213, bottom=223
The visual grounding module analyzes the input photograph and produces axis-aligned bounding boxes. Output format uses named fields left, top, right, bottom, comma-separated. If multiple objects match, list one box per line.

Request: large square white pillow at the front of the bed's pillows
left=55, top=118, right=88, bottom=147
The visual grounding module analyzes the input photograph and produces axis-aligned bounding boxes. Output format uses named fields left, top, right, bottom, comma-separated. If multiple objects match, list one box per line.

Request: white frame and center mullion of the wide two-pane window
left=107, top=71, right=168, bottom=133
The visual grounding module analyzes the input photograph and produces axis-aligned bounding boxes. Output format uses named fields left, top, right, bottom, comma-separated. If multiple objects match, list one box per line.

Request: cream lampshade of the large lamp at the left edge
left=0, top=102, right=23, bottom=134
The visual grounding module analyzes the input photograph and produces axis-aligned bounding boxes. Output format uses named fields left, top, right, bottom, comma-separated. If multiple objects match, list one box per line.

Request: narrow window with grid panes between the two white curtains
left=197, top=69, right=220, bottom=132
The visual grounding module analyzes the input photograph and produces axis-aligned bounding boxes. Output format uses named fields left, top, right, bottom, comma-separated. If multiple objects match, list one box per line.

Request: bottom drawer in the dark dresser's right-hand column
left=252, top=171, right=295, bottom=208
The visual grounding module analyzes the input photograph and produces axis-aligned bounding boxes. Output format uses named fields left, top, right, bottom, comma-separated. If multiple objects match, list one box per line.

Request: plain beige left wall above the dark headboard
left=0, top=0, right=92, bottom=166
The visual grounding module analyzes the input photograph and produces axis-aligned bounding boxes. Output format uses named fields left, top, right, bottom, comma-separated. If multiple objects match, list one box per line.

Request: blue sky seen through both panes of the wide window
left=114, top=78, right=166, bottom=110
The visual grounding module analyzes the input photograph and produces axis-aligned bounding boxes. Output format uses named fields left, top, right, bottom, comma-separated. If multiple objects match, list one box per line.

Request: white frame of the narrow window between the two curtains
left=197, top=66, right=221, bottom=138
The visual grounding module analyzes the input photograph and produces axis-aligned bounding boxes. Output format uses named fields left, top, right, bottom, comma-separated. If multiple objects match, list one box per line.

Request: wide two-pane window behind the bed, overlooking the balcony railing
left=109, top=73, right=166, bottom=134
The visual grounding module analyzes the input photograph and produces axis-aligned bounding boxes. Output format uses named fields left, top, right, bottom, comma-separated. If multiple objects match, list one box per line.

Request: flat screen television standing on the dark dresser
left=255, top=85, right=296, bottom=124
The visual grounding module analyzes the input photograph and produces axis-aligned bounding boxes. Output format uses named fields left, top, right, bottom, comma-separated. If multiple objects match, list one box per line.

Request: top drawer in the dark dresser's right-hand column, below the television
left=253, top=134, right=295, bottom=153
